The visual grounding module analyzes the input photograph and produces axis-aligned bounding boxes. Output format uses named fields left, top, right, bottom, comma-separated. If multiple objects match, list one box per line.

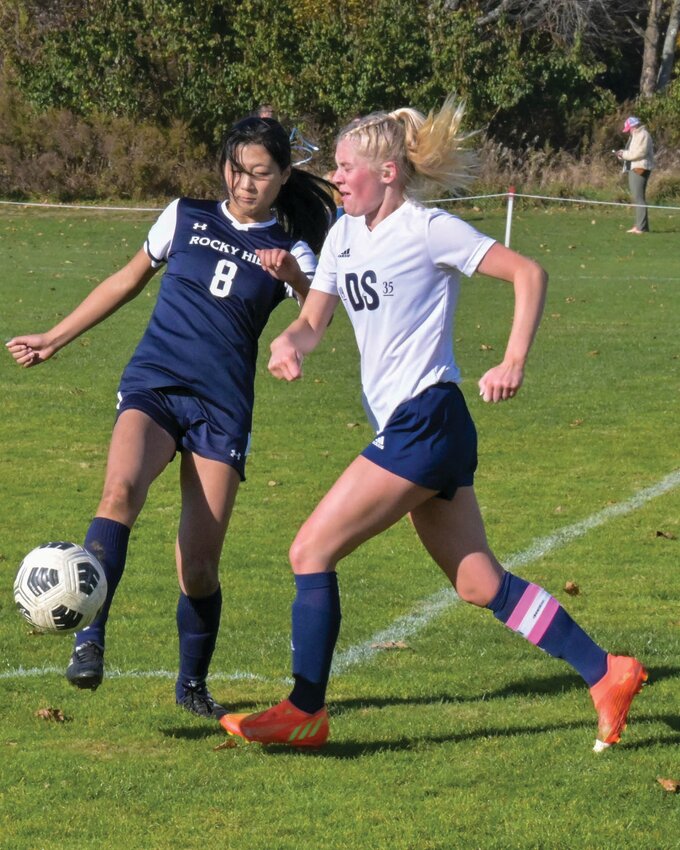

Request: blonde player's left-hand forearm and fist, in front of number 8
left=269, top=289, right=340, bottom=381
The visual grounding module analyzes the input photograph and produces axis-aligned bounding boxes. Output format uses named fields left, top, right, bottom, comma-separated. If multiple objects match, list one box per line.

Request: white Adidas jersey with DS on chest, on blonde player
left=312, top=201, right=495, bottom=431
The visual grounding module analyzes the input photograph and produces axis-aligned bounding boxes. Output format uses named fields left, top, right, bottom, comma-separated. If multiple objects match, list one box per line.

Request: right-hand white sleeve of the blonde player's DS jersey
left=427, top=210, right=496, bottom=277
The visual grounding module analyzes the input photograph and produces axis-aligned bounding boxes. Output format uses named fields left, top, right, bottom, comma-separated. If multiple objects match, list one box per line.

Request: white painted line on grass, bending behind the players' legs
left=0, top=470, right=680, bottom=682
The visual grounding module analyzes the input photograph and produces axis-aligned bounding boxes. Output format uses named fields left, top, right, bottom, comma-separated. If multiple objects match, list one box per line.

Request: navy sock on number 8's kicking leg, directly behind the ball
left=75, top=517, right=130, bottom=648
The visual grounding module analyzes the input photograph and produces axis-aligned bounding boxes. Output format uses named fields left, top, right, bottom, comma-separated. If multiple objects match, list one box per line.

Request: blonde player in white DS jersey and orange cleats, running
left=220, top=99, right=647, bottom=751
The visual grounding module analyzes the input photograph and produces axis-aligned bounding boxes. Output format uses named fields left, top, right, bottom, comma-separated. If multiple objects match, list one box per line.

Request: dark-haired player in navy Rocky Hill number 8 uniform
left=7, top=117, right=335, bottom=718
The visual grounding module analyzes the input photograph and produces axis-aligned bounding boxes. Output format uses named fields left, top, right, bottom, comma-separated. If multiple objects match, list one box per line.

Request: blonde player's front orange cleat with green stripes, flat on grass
left=220, top=699, right=328, bottom=747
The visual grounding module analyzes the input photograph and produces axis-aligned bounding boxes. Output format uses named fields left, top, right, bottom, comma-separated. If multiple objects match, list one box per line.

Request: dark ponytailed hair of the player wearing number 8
left=219, top=116, right=336, bottom=254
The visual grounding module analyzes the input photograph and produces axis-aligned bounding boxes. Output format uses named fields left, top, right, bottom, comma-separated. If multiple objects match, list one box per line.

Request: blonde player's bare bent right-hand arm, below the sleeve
left=477, top=243, right=548, bottom=402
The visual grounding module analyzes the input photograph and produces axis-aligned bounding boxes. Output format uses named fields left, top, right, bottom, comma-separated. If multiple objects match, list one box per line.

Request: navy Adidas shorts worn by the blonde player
left=361, top=383, right=477, bottom=499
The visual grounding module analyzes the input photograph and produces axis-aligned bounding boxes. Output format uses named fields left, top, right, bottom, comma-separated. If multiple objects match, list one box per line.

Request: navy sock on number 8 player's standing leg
left=175, top=586, right=222, bottom=699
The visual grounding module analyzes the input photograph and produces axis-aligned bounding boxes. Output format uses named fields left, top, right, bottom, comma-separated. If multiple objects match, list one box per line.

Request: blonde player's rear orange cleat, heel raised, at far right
left=590, top=655, right=647, bottom=753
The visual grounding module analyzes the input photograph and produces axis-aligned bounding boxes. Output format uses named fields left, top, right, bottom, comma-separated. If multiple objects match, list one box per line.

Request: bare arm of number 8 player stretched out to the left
left=6, top=245, right=156, bottom=368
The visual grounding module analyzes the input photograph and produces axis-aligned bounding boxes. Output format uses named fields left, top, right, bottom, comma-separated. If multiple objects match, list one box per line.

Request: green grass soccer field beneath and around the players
left=0, top=200, right=680, bottom=850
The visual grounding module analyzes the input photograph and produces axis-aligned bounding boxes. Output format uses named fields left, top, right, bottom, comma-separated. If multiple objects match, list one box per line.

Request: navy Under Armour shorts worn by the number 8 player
left=117, top=387, right=250, bottom=481
